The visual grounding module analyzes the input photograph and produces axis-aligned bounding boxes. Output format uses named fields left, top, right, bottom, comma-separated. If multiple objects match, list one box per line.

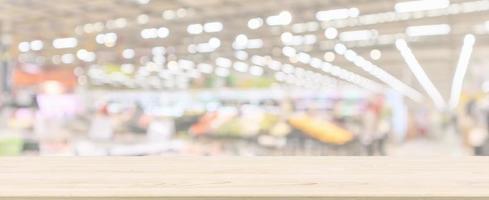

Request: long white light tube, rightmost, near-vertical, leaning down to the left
left=449, top=34, right=475, bottom=109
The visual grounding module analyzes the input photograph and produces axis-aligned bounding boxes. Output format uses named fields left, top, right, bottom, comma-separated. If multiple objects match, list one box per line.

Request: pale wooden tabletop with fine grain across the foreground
left=0, top=157, right=489, bottom=200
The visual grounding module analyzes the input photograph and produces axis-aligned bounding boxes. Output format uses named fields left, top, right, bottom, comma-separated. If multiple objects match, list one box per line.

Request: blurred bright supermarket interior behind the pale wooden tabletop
left=0, top=0, right=489, bottom=156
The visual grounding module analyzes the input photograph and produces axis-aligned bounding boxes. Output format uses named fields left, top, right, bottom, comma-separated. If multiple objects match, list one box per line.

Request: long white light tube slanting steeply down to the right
left=396, top=39, right=446, bottom=109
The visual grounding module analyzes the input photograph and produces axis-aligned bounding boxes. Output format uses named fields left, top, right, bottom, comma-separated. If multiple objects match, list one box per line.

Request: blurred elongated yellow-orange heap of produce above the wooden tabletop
left=289, top=115, right=353, bottom=144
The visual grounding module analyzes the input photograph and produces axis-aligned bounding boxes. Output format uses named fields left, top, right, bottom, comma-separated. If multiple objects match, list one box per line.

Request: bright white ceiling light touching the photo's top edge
left=394, top=0, right=450, bottom=13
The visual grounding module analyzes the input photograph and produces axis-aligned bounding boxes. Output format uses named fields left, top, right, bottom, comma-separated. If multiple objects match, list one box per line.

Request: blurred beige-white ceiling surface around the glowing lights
left=0, top=0, right=489, bottom=105
